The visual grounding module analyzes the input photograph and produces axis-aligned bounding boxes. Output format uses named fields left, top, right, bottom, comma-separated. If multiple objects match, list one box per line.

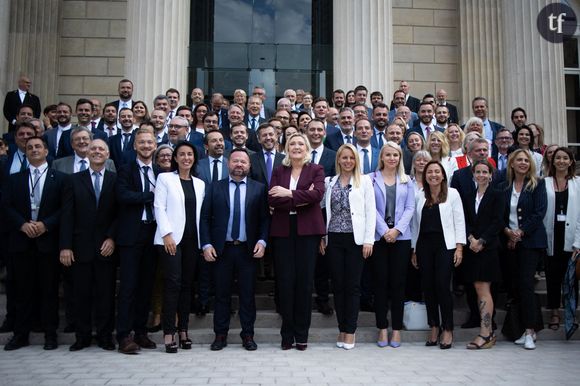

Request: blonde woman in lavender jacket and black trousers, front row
left=370, top=141, right=415, bottom=348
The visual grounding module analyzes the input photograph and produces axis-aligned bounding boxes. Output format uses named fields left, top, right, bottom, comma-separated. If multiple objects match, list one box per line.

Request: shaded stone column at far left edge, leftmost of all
left=0, top=0, right=60, bottom=131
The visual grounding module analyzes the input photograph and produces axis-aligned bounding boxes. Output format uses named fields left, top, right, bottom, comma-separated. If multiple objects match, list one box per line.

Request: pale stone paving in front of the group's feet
left=0, top=339, right=580, bottom=386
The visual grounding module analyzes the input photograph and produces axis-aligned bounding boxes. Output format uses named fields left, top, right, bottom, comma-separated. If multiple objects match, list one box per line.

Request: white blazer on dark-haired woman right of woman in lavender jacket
left=411, top=188, right=467, bottom=250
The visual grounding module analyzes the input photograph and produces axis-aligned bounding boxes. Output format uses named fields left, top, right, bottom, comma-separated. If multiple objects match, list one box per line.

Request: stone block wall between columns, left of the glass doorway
left=58, top=0, right=127, bottom=108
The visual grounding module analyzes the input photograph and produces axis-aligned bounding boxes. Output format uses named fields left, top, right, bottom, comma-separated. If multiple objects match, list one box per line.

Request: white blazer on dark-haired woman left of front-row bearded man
left=154, top=172, right=205, bottom=248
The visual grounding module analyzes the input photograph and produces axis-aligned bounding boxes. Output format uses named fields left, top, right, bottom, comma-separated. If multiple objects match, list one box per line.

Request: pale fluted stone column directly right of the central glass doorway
left=332, top=0, right=393, bottom=93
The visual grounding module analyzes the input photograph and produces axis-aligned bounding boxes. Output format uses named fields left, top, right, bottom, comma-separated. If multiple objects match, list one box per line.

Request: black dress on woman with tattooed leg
left=461, top=187, right=503, bottom=282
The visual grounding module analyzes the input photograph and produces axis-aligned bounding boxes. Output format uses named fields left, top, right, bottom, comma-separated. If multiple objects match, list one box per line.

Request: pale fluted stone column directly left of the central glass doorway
left=125, top=0, right=190, bottom=105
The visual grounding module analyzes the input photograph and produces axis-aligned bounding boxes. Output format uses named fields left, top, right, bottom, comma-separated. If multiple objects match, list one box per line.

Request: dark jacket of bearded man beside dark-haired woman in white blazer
left=115, top=160, right=159, bottom=246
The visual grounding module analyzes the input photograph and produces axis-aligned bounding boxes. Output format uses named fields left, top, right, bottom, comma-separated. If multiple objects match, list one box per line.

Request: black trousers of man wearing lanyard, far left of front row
left=11, top=247, right=58, bottom=335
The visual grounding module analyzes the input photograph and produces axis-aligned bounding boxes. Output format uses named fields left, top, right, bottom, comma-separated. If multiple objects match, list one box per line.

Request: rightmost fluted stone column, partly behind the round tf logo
left=501, top=0, right=568, bottom=145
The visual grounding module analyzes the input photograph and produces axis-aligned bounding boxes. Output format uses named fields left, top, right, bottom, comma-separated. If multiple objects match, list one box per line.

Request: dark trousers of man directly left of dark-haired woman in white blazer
left=117, top=223, right=157, bottom=342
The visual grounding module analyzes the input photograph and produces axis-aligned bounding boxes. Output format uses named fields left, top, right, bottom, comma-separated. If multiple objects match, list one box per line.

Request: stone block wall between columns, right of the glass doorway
left=392, top=0, right=463, bottom=116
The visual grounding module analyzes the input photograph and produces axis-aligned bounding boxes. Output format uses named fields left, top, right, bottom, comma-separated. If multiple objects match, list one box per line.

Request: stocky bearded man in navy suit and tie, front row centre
left=200, top=149, right=270, bottom=351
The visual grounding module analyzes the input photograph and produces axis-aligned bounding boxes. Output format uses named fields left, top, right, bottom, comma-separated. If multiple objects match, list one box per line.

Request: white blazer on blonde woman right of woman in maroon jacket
left=324, top=175, right=377, bottom=245
